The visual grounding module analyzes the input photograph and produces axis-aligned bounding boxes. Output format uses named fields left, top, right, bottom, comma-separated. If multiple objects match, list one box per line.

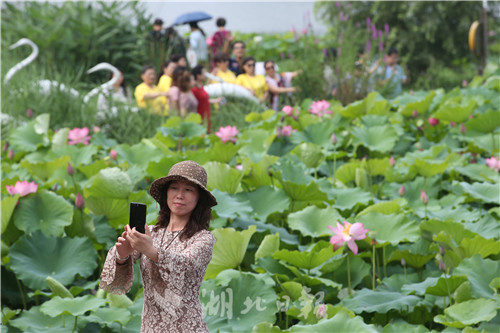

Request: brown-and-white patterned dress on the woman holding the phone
left=99, top=227, right=215, bottom=333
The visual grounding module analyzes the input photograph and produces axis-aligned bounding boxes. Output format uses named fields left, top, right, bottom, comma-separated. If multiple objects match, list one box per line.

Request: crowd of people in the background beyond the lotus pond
left=100, top=18, right=407, bottom=131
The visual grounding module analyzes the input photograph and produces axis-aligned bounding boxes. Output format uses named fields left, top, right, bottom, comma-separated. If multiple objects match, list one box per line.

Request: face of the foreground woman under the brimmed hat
left=167, top=180, right=200, bottom=217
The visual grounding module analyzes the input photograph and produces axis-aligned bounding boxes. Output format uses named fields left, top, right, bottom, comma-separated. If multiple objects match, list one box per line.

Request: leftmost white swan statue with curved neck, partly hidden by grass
left=3, top=38, right=80, bottom=97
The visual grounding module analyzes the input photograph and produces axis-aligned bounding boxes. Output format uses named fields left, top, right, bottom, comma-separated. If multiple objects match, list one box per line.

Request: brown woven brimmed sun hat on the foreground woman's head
left=149, top=161, right=217, bottom=207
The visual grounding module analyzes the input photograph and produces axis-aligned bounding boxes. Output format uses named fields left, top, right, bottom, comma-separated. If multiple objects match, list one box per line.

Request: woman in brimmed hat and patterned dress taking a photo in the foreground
left=99, top=161, right=217, bottom=333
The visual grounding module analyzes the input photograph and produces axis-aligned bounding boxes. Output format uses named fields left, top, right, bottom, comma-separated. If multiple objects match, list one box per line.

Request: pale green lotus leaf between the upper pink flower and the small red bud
left=351, top=125, right=398, bottom=153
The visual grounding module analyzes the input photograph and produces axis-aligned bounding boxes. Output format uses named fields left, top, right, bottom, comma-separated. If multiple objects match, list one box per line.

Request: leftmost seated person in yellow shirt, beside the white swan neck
left=134, top=65, right=168, bottom=116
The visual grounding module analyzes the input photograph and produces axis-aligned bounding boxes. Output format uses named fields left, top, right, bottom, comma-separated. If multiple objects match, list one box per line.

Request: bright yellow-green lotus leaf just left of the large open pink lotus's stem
left=273, top=241, right=336, bottom=269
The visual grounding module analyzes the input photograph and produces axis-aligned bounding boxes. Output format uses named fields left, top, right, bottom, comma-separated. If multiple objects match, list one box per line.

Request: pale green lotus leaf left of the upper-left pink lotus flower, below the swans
left=9, top=114, right=50, bottom=152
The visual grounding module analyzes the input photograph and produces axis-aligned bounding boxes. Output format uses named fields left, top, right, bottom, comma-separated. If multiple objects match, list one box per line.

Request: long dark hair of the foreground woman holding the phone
left=155, top=182, right=212, bottom=241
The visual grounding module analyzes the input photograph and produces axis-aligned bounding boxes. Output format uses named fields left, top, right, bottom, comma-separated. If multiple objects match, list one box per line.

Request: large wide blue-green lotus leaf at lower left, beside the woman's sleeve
left=9, top=232, right=97, bottom=290
